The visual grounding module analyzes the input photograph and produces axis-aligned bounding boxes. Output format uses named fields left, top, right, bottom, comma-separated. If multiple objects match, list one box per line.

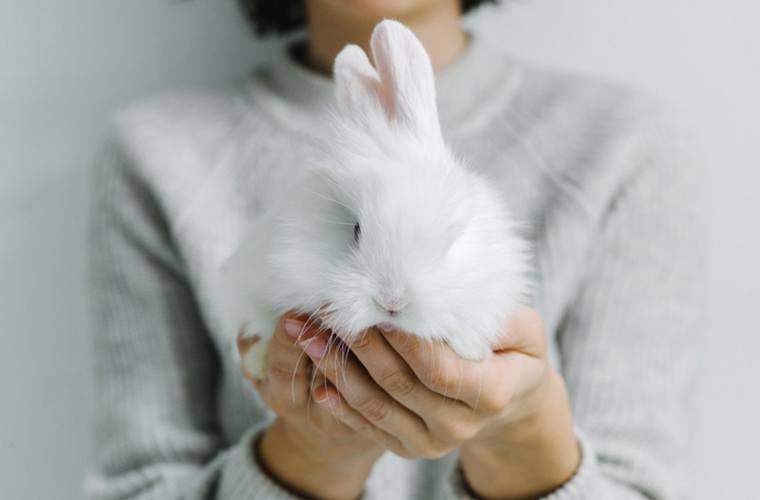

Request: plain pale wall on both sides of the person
left=0, top=0, right=760, bottom=500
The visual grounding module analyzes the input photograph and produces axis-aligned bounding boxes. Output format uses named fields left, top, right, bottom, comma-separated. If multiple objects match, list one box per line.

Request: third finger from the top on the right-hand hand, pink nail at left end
left=302, top=334, right=428, bottom=448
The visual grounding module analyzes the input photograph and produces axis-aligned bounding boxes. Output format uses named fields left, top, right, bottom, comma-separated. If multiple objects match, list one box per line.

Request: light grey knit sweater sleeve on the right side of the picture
left=451, top=111, right=706, bottom=500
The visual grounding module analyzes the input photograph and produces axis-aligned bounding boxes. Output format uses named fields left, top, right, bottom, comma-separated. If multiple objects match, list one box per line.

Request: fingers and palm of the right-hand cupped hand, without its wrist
left=301, top=310, right=548, bottom=458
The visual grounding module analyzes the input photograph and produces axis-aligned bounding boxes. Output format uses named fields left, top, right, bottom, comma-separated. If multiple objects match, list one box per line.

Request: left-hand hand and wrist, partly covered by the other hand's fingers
left=238, top=315, right=394, bottom=499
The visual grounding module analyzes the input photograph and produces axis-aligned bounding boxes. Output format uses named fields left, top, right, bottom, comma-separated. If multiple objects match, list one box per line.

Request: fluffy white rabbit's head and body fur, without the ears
left=272, top=135, right=524, bottom=357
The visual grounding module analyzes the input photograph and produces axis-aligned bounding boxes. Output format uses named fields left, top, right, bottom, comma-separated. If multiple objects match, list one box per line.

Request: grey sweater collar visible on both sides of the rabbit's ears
left=250, top=36, right=520, bottom=138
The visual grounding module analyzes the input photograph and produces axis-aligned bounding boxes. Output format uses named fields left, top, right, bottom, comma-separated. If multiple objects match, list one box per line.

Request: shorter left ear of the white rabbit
left=333, top=45, right=384, bottom=117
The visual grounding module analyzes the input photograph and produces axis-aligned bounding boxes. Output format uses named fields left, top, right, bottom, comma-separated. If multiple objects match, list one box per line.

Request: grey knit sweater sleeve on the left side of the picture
left=85, top=141, right=300, bottom=500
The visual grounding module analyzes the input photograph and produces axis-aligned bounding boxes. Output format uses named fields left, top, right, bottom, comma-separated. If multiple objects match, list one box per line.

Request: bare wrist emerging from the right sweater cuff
left=460, top=368, right=580, bottom=499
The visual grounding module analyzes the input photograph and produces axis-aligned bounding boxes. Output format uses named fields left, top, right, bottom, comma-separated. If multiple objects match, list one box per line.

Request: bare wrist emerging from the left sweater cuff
left=254, top=419, right=379, bottom=500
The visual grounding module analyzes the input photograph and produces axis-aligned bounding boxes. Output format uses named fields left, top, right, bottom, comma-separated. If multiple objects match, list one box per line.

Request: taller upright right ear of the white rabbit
left=370, top=20, right=441, bottom=143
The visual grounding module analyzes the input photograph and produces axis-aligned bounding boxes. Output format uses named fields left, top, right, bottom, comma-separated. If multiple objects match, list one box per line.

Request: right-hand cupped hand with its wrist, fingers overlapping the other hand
left=305, top=309, right=580, bottom=498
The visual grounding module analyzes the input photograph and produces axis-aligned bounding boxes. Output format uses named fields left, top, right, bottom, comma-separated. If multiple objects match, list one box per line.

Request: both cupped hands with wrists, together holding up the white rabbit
left=241, top=309, right=580, bottom=498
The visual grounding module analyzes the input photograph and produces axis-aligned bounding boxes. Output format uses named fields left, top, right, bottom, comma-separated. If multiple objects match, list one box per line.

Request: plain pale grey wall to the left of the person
left=0, top=0, right=274, bottom=500
